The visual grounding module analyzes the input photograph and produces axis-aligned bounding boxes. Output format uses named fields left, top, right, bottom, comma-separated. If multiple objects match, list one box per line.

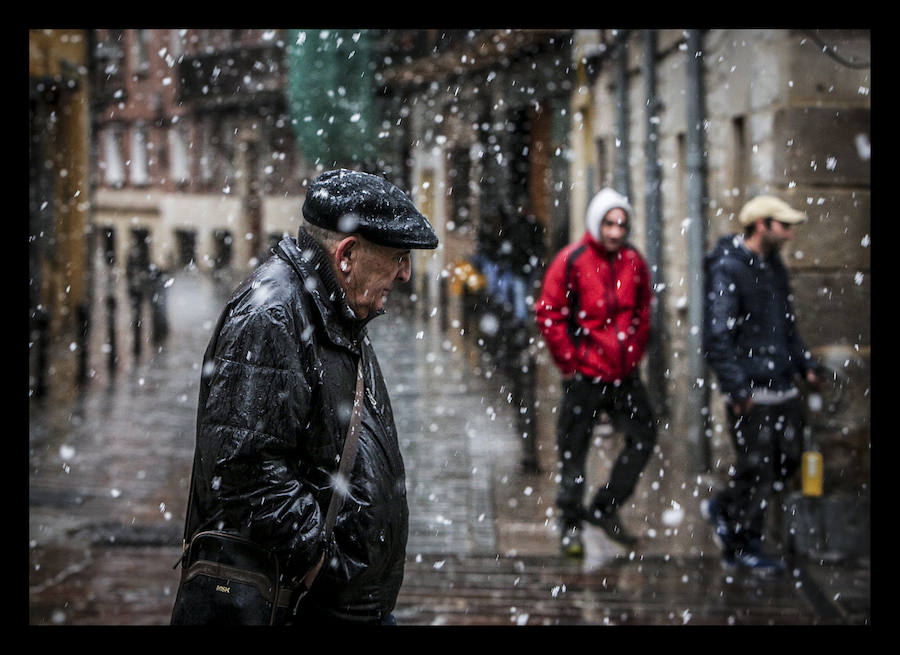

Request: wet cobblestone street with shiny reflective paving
left=28, top=273, right=871, bottom=626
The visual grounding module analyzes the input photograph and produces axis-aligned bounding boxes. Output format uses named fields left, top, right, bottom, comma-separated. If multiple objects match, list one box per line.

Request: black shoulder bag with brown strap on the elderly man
left=171, top=359, right=363, bottom=625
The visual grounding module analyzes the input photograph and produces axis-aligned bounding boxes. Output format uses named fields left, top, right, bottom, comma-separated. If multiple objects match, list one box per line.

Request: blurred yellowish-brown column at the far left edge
left=28, top=29, right=91, bottom=395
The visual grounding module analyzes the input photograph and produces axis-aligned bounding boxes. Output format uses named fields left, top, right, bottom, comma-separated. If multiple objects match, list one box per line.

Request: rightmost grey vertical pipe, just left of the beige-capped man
left=686, top=30, right=710, bottom=472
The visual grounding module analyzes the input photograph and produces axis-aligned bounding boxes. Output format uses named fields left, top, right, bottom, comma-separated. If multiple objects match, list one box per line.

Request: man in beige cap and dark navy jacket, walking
left=703, top=195, right=819, bottom=574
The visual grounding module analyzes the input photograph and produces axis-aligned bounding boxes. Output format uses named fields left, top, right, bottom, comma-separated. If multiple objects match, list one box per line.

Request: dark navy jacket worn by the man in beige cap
left=704, top=235, right=818, bottom=401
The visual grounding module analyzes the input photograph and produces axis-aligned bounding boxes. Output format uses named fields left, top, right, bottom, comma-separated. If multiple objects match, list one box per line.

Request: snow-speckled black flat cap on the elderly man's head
left=303, top=169, right=438, bottom=249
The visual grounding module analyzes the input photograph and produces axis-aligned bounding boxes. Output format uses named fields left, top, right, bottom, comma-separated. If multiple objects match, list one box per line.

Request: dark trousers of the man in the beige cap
left=716, top=398, right=804, bottom=549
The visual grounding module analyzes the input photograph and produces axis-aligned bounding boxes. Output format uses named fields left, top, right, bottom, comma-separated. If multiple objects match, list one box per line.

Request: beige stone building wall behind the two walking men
left=570, top=29, right=871, bottom=492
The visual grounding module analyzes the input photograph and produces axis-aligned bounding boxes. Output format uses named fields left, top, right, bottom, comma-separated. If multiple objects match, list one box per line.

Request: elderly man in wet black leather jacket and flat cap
left=173, top=169, right=438, bottom=626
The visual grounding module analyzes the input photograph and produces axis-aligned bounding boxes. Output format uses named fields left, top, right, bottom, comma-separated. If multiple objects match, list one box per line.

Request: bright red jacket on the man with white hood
left=535, top=232, right=652, bottom=382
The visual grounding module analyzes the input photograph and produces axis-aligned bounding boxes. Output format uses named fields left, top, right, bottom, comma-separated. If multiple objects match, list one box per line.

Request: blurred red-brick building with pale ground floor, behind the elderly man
left=93, top=29, right=310, bottom=270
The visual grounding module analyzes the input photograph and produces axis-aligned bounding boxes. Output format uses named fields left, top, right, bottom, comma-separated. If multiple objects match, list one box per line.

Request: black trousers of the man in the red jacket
left=556, top=374, right=656, bottom=526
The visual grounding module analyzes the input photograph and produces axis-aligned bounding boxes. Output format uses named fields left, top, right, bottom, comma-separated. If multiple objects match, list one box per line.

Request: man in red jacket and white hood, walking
left=535, top=189, right=656, bottom=557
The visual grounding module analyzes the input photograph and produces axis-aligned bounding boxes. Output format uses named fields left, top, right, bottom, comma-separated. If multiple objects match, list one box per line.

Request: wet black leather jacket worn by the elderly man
left=185, top=231, right=408, bottom=621
